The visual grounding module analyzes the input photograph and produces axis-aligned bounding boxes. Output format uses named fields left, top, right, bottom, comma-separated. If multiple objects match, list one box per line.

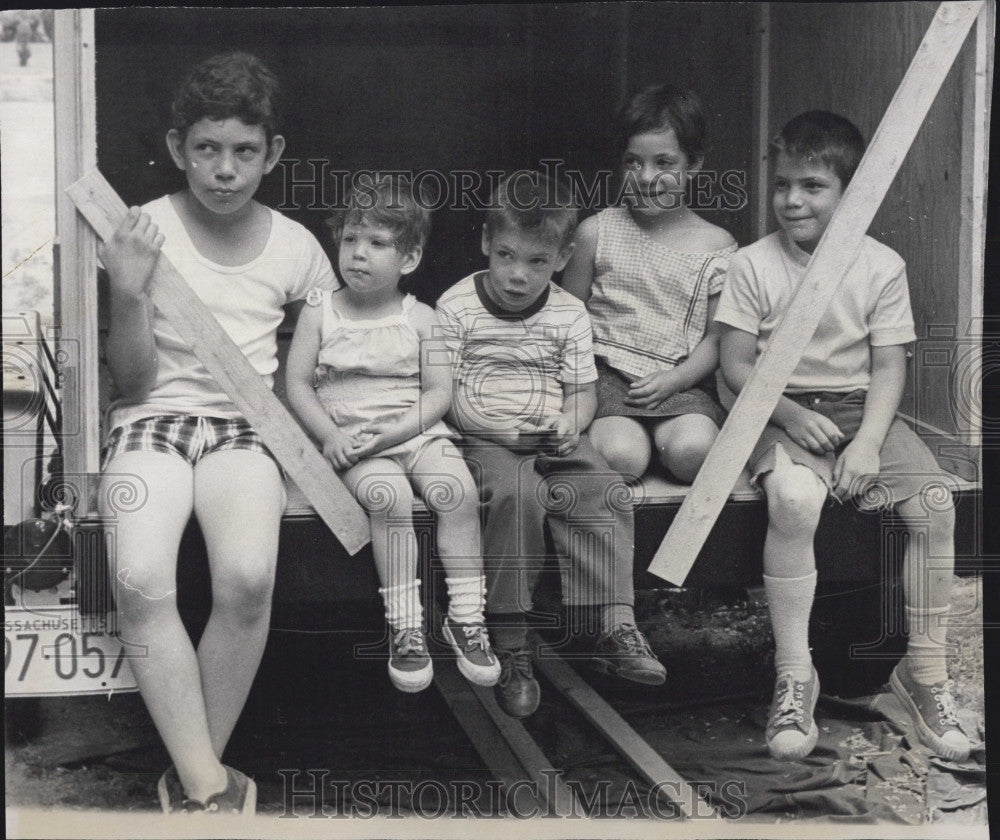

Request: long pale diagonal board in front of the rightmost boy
left=649, top=0, right=983, bottom=586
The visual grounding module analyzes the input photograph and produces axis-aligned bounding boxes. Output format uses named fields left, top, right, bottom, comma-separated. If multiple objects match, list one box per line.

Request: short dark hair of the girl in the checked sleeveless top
left=614, top=84, right=706, bottom=162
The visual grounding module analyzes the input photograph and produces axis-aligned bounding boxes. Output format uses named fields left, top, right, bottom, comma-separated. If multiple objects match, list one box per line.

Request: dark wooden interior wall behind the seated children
left=96, top=2, right=982, bottom=452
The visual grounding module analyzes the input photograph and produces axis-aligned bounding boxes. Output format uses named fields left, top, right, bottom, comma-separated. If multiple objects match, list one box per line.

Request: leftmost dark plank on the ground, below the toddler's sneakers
left=434, top=662, right=544, bottom=815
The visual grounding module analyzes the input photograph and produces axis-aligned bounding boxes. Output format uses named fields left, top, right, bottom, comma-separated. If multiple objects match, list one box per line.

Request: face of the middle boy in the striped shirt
left=483, top=229, right=573, bottom=312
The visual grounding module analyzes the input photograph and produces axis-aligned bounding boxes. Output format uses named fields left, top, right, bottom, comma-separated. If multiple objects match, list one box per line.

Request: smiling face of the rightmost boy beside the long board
left=773, top=152, right=844, bottom=254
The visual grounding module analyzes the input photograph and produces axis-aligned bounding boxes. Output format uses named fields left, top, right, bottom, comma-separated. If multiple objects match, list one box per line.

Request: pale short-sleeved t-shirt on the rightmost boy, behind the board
left=715, top=231, right=916, bottom=394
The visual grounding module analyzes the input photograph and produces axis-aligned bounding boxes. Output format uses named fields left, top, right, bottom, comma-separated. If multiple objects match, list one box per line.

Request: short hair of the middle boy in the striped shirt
left=486, top=169, right=577, bottom=251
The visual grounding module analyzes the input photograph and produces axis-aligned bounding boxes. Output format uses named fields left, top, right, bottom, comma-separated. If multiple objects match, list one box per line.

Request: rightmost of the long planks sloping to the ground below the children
left=531, top=633, right=718, bottom=818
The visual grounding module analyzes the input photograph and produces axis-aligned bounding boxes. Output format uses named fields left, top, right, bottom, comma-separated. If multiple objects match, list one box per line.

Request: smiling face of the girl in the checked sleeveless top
left=622, top=128, right=701, bottom=216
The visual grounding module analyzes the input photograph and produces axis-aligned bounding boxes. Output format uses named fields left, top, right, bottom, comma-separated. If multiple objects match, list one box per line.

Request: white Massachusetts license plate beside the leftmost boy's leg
left=4, top=605, right=136, bottom=697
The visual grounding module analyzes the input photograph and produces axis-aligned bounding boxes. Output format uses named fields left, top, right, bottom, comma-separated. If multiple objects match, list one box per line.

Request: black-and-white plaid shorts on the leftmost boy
left=101, top=414, right=281, bottom=470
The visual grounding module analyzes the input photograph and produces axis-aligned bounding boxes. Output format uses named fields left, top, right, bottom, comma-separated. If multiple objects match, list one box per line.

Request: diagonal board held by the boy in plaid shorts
left=66, top=171, right=370, bottom=554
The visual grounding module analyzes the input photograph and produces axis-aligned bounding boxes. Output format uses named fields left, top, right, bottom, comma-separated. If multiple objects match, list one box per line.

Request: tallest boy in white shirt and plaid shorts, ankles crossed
left=99, top=53, right=336, bottom=813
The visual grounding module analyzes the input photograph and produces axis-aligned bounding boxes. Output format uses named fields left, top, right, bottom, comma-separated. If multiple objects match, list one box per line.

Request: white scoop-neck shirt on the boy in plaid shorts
left=107, top=196, right=339, bottom=430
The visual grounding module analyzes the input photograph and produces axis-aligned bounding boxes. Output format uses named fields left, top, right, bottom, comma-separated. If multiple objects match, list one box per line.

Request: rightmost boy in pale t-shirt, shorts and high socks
left=715, top=111, right=970, bottom=760
